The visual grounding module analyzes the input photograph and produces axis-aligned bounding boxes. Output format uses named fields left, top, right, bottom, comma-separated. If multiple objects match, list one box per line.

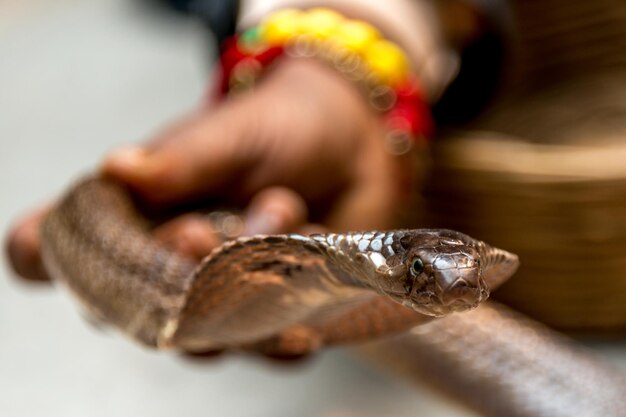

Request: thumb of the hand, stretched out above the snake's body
left=101, top=95, right=261, bottom=204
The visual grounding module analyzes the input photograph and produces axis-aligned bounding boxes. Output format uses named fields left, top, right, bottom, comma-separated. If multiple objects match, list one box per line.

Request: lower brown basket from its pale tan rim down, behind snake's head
left=426, top=134, right=626, bottom=335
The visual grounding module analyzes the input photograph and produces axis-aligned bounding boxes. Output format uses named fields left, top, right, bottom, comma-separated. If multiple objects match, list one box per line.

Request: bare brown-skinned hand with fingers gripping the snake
left=7, top=60, right=417, bottom=280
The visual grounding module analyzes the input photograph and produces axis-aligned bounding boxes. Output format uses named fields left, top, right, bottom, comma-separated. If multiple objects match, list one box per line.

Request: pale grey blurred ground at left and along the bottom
left=0, top=0, right=472, bottom=417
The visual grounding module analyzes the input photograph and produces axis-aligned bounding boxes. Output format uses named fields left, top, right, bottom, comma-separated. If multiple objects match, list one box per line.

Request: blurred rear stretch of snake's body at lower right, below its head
left=365, top=301, right=626, bottom=417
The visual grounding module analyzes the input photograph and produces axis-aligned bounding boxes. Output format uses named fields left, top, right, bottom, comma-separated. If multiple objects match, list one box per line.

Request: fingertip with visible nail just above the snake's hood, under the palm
left=244, top=187, right=307, bottom=235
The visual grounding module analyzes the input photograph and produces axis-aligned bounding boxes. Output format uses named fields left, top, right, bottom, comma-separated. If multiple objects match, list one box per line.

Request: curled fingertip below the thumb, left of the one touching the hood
left=154, top=214, right=222, bottom=261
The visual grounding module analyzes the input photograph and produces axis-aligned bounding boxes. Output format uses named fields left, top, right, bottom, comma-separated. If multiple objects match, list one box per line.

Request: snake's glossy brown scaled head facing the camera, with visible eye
left=380, top=229, right=518, bottom=316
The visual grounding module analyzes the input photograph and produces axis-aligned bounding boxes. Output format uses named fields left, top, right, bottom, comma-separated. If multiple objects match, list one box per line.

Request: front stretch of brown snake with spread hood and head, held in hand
left=42, top=179, right=517, bottom=353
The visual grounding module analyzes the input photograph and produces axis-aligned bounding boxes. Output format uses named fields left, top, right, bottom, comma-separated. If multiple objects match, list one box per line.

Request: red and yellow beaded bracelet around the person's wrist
left=220, top=8, right=433, bottom=154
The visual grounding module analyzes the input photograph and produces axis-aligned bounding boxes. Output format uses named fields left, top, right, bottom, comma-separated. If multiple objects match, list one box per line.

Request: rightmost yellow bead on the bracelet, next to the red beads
left=364, top=40, right=409, bottom=86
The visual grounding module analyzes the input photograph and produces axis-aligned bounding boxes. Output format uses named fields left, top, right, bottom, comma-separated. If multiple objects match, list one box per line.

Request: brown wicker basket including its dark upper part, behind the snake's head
left=425, top=0, right=626, bottom=336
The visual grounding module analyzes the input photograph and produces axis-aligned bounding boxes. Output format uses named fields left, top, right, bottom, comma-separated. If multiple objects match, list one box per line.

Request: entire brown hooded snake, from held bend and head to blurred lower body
left=41, top=177, right=626, bottom=417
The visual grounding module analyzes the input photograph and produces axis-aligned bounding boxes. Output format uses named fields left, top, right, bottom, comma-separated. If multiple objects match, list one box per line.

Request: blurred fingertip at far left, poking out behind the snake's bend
left=5, top=206, right=50, bottom=281
